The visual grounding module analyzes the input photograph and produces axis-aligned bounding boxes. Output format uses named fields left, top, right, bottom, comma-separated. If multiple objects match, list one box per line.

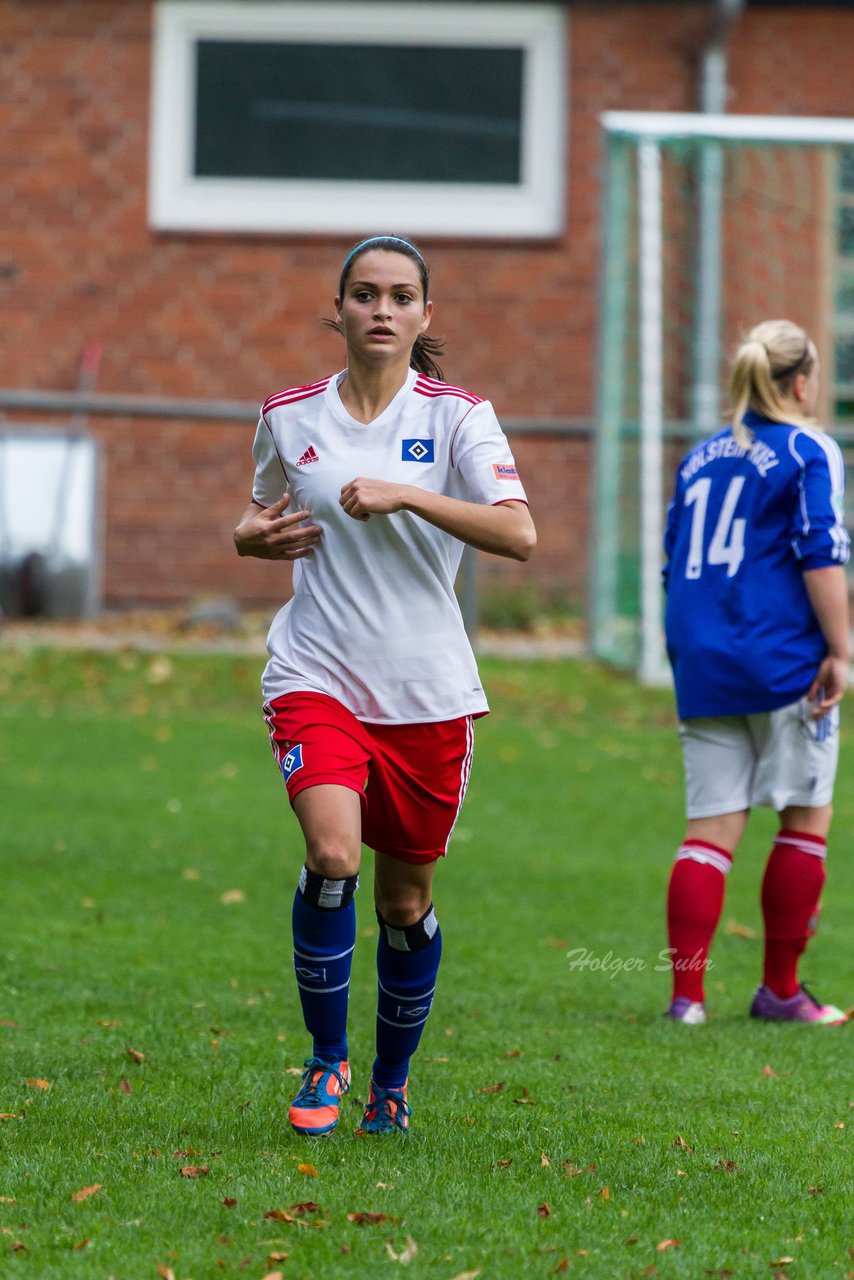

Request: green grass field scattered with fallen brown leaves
left=0, top=649, right=854, bottom=1280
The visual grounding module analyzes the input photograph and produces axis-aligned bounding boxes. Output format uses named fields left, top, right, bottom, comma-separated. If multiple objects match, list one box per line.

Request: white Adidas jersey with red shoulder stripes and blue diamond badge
left=252, top=369, right=526, bottom=724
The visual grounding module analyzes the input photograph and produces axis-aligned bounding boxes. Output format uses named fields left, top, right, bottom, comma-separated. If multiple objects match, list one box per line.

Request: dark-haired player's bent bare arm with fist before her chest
left=339, top=476, right=536, bottom=561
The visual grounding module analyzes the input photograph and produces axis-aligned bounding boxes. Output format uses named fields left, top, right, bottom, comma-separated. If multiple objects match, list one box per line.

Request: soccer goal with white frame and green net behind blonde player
left=590, top=111, right=854, bottom=682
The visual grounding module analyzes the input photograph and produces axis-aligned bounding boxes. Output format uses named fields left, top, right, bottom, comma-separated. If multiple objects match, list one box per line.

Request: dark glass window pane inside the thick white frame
left=195, top=40, right=524, bottom=184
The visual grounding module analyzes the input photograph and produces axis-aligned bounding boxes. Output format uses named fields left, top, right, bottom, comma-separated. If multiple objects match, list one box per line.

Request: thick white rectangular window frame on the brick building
left=149, top=0, right=568, bottom=237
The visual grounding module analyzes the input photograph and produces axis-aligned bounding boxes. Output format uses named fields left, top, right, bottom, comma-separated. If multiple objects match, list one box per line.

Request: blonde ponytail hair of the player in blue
left=730, top=320, right=816, bottom=448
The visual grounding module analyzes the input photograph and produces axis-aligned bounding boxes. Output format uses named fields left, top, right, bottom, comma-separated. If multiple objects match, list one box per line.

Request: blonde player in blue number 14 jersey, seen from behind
left=665, top=320, right=850, bottom=1025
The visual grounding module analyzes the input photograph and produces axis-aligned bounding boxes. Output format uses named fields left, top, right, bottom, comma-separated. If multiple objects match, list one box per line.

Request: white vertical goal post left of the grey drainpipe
left=638, top=138, right=665, bottom=684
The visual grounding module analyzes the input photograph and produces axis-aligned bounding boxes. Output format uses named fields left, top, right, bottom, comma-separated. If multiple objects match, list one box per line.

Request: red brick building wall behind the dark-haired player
left=0, top=0, right=854, bottom=604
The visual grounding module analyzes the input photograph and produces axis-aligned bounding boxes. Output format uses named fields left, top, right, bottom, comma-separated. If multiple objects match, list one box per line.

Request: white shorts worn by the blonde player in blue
left=679, top=698, right=839, bottom=818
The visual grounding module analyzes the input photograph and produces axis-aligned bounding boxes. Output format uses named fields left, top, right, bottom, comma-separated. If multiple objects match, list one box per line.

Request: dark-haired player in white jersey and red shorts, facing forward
left=234, top=236, right=535, bottom=1134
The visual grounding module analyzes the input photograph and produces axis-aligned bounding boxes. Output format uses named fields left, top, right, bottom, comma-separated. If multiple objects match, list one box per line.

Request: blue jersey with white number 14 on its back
left=663, top=413, right=849, bottom=719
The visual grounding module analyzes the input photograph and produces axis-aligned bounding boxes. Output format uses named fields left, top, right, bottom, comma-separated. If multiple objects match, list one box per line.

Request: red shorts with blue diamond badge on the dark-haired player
left=264, top=694, right=474, bottom=863
